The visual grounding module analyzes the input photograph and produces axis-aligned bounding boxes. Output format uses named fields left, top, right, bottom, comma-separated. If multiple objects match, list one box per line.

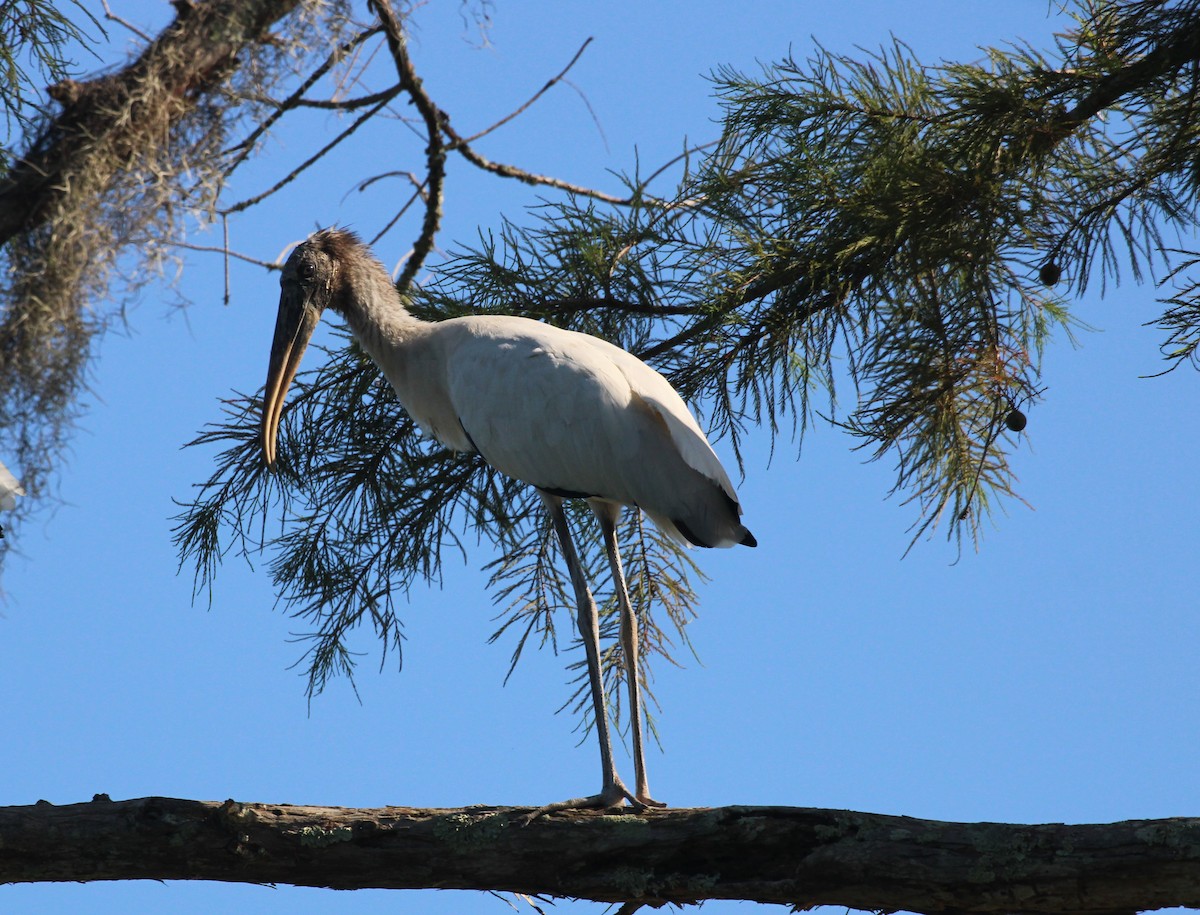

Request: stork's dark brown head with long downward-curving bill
left=262, top=228, right=362, bottom=467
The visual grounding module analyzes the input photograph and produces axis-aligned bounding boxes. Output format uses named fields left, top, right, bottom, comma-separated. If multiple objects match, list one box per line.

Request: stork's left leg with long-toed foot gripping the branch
left=529, top=490, right=643, bottom=819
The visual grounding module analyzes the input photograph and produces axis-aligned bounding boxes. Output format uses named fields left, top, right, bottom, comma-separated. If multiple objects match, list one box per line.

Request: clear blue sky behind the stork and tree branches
left=0, top=0, right=1200, bottom=915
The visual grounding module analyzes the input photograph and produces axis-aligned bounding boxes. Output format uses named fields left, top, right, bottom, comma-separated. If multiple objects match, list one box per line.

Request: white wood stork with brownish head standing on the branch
left=262, top=228, right=756, bottom=811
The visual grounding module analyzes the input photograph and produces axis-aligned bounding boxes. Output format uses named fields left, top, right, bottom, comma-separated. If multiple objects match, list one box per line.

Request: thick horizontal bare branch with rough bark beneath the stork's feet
left=0, top=795, right=1200, bottom=915
